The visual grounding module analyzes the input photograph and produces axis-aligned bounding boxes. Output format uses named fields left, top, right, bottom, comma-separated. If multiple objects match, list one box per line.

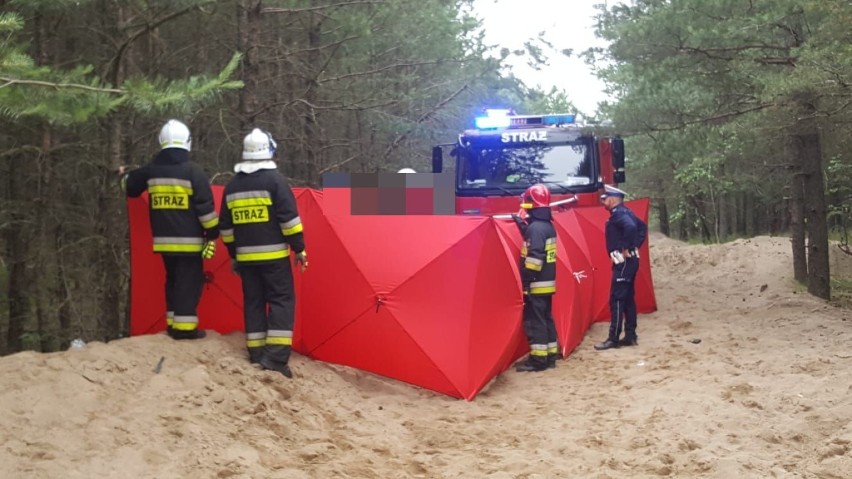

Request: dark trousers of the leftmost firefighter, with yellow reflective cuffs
left=161, top=253, right=204, bottom=332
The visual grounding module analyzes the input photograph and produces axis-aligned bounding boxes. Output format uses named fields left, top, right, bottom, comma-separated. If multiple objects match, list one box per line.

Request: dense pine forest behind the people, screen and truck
left=0, top=0, right=852, bottom=354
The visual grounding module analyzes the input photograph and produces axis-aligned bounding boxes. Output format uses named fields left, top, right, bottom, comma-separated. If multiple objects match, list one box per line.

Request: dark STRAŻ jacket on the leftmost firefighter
left=125, top=148, right=219, bottom=254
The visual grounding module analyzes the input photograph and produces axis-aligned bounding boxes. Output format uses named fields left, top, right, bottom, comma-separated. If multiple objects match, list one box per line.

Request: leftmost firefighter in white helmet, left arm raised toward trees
left=119, top=120, right=219, bottom=339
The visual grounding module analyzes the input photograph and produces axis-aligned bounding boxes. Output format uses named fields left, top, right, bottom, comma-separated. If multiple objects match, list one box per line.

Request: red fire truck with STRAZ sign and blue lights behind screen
left=432, top=109, right=625, bottom=216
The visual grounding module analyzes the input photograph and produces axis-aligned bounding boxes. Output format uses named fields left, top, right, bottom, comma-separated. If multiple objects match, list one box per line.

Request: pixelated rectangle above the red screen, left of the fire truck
left=322, top=173, right=456, bottom=215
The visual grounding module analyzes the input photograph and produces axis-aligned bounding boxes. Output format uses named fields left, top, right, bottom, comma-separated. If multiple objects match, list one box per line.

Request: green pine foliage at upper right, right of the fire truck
left=584, top=0, right=852, bottom=244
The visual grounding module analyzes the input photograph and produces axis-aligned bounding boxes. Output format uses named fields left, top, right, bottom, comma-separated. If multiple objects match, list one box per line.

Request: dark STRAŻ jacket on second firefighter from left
left=220, top=169, right=305, bottom=264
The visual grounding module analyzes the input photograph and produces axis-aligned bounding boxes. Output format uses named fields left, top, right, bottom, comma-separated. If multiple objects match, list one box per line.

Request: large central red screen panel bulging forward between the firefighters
left=297, top=188, right=523, bottom=399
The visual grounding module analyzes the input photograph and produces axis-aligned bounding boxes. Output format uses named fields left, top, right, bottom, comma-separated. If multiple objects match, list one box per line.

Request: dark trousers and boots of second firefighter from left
left=239, top=257, right=296, bottom=366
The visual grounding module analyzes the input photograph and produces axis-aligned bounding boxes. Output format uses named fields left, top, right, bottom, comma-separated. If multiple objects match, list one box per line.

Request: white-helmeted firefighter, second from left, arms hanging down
left=220, top=128, right=308, bottom=378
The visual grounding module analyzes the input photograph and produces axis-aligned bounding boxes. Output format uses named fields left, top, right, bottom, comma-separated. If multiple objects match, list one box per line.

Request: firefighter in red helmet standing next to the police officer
left=516, top=184, right=559, bottom=372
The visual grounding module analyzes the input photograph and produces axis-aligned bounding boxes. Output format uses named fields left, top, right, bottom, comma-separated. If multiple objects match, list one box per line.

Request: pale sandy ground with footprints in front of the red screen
left=0, top=235, right=852, bottom=479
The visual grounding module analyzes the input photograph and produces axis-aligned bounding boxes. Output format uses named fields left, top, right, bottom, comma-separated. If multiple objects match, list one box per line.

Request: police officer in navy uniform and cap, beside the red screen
left=595, top=185, right=647, bottom=351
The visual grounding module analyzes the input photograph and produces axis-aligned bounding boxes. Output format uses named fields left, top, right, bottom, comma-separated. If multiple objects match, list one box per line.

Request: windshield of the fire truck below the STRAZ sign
left=456, top=141, right=596, bottom=196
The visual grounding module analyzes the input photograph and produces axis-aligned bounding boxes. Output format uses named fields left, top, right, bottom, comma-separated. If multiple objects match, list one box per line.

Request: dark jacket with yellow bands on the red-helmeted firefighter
left=521, top=208, right=556, bottom=294
